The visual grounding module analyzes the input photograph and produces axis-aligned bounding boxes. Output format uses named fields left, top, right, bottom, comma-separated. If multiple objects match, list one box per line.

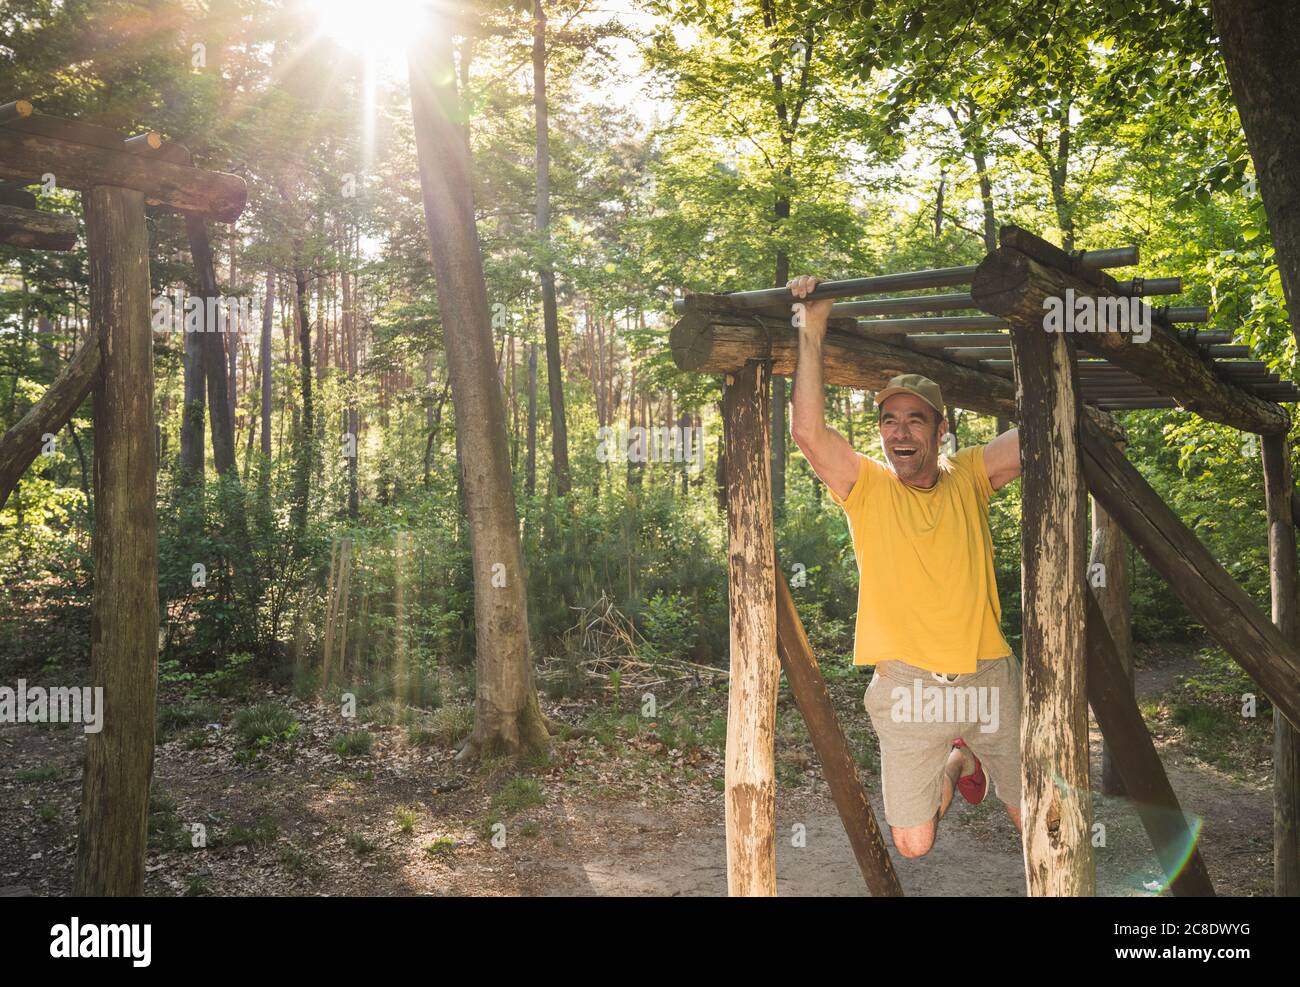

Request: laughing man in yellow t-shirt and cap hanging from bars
left=789, top=276, right=1021, bottom=857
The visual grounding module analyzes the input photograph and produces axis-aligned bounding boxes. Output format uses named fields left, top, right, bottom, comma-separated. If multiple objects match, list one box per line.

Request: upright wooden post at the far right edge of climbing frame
left=1260, top=436, right=1300, bottom=897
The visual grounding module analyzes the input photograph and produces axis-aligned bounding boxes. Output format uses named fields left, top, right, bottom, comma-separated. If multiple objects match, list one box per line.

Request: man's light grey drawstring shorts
left=862, top=655, right=1021, bottom=828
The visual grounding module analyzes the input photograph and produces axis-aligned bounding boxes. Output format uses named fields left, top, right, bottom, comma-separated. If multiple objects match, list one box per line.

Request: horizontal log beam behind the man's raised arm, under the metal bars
left=668, top=315, right=1125, bottom=441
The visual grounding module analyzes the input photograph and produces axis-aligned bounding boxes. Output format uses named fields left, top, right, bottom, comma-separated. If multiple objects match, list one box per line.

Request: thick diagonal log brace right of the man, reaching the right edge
left=1082, top=421, right=1300, bottom=726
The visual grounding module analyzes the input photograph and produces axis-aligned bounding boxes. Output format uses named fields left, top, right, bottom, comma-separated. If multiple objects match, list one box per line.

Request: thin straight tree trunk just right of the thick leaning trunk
left=533, top=0, right=569, bottom=497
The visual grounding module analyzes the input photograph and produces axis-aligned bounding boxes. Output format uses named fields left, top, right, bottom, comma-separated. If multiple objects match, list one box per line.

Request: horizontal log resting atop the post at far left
left=0, top=127, right=248, bottom=222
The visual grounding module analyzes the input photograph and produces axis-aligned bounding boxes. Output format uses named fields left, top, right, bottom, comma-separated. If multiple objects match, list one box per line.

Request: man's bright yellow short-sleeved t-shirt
left=831, top=446, right=1011, bottom=675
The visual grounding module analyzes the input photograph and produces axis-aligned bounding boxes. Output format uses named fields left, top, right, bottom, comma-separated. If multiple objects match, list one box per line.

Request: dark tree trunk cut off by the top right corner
left=1210, top=0, right=1300, bottom=353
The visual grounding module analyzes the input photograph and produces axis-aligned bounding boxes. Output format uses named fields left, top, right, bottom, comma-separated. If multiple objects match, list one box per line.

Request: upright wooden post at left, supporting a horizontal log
left=74, top=187, right=159, bottom=896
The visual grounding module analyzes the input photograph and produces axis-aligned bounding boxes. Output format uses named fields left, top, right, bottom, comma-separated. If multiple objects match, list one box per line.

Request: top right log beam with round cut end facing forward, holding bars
left=971, top=238, right=1290, bottom=433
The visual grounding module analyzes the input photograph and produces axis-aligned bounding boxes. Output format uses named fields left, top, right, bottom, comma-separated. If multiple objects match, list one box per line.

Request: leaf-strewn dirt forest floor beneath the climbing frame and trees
left=0, top=644, right=1271, bottom=897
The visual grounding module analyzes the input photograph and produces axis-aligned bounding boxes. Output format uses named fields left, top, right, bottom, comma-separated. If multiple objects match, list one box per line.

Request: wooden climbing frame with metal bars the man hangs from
left=670, top=226, right=1300, bottom=896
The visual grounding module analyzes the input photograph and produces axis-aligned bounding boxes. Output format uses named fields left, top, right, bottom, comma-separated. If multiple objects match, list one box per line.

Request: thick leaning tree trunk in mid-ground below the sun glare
left=408, top=23, right=550, bottom=758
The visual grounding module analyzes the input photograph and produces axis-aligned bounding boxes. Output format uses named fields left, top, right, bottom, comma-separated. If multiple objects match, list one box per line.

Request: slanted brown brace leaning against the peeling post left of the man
left=775, top=572, right=902, bottom=897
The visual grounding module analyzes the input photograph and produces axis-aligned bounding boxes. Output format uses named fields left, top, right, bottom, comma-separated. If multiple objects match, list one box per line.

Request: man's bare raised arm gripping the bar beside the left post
left=789, top=274, right=858, bottom=501
